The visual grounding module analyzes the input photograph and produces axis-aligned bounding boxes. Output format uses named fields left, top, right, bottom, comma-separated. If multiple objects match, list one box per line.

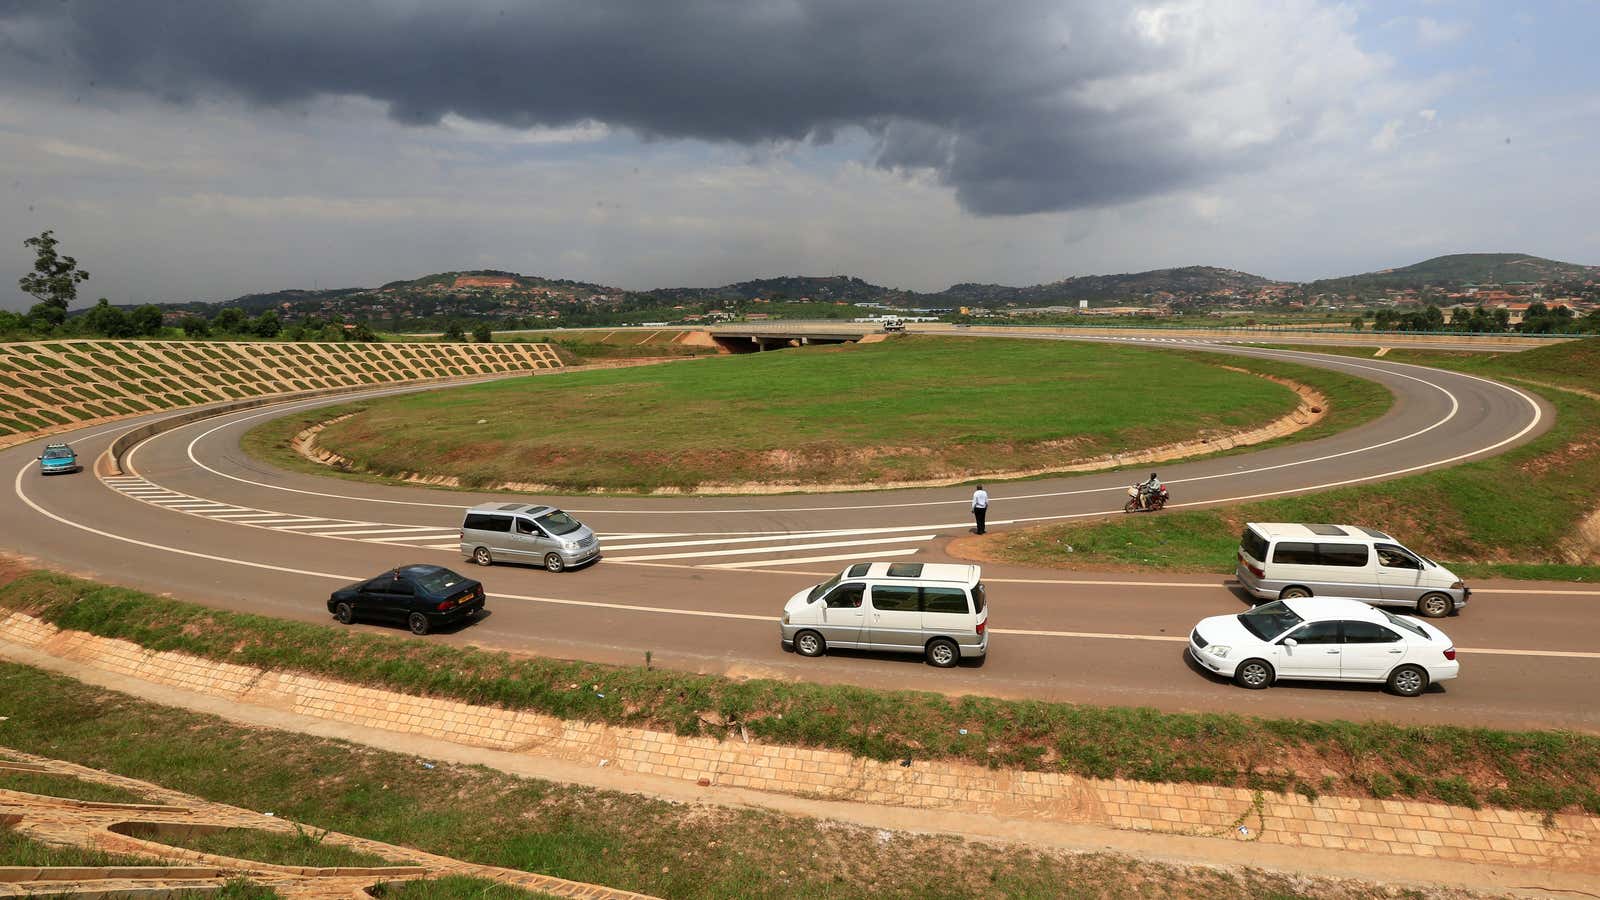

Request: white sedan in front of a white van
left=1189, top=597, right=1461, bottom=697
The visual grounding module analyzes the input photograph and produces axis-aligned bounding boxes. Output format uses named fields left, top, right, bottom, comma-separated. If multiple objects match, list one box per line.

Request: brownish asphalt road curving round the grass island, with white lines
left=0, top=339, right=1600, bottom=732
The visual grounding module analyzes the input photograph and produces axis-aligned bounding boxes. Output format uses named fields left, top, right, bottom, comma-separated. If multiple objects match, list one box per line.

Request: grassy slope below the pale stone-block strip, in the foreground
left=0, top=663, right=1459, bottom=900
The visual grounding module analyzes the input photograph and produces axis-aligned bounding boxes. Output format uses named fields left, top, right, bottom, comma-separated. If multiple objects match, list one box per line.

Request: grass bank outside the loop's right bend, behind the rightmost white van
left=984, top=340, right=1600, bottom=581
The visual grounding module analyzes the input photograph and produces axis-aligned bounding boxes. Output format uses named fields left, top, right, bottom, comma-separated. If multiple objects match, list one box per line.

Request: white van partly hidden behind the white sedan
left=1234, top=522, right=1472, bottom=618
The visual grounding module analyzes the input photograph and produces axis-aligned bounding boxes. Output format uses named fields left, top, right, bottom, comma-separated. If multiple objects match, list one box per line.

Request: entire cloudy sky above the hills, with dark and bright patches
left=0, top=0, right=1600, bottom=309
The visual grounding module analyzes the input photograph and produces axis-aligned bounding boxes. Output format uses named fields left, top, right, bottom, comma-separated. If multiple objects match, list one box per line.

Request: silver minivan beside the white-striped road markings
left=461, top=503, right=600, bottom=572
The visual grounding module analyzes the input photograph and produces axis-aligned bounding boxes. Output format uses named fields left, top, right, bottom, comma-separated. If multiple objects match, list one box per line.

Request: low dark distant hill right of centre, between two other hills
left=933, top=266, right=1278, bottom=306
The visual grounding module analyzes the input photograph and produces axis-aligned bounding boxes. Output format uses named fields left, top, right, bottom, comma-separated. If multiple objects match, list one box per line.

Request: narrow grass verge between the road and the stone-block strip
left=0, top=572, right=1600, bottom=814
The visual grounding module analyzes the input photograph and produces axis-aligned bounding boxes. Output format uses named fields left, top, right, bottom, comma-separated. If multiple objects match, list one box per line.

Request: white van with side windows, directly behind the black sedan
left=779, top=562, right=989, bottom=668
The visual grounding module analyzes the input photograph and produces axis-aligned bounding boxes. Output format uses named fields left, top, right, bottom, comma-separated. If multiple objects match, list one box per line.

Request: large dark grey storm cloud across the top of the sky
left=0, top=0, right=1337, bottom=215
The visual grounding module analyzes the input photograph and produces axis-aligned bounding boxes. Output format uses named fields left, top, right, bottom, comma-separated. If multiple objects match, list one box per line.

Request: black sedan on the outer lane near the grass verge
left=328, top=565, right=483, bottom=634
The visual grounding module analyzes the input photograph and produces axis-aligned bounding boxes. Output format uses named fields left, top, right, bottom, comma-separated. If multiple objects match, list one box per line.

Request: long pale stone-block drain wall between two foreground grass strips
left=0, top=613, right=1600, bottom=873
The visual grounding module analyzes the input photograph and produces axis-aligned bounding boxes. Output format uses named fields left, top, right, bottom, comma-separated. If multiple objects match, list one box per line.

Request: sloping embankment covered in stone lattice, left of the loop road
left=0, top=340, right=562, bottom=447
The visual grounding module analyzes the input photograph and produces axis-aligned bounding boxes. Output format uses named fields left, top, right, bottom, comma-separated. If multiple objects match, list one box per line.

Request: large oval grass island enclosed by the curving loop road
left=246, top=338, right=1363, bottom=490
